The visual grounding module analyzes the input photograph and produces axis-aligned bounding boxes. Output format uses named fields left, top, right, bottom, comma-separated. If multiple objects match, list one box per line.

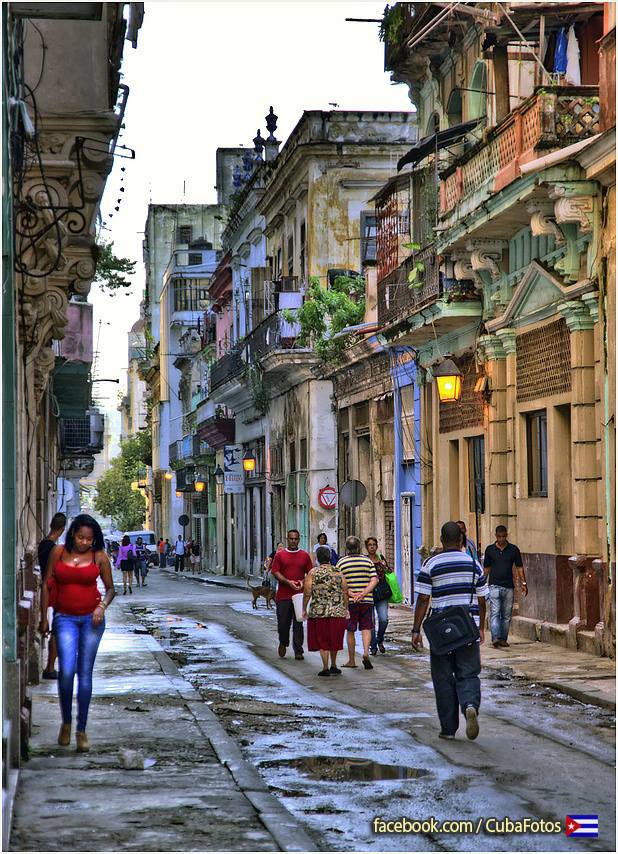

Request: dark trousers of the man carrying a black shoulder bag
left=430, top=643, right=481, bottom=735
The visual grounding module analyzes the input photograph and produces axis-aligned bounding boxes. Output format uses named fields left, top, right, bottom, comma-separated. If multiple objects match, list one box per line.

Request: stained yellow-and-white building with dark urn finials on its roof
left=211, top=111, right=416, bottom=573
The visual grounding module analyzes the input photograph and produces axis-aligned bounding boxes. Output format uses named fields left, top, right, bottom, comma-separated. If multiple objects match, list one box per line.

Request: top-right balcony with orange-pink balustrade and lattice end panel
left=440, top=86, right=600, bottom=225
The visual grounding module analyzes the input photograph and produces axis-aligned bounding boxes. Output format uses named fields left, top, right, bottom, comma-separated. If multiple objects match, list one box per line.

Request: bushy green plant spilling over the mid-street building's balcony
left=283, top=276, right=365, bottom=364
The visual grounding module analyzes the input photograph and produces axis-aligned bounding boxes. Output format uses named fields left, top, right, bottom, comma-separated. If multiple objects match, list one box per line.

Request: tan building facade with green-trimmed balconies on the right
left=377, top=3, right=611, bottom=652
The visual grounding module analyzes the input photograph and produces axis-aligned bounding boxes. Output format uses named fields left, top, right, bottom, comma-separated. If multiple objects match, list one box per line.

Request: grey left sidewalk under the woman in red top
left=10, top=598, right=316, bottom=851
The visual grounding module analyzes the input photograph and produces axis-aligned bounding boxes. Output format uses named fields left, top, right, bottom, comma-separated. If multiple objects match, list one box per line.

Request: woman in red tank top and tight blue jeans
left=40, top=513, right=116, bottom=753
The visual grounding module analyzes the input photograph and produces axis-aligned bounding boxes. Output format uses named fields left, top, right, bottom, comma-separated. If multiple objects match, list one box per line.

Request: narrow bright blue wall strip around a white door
left=390, top=347, right=422, bottom=605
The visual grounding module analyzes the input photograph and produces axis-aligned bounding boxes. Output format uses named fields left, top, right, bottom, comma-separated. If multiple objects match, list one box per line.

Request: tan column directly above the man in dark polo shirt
left=479, top=335, right=509, bottom=531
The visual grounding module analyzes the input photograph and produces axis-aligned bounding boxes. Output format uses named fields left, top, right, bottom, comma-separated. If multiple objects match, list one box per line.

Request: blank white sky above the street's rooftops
left=91, top=0, right=411, bottom=442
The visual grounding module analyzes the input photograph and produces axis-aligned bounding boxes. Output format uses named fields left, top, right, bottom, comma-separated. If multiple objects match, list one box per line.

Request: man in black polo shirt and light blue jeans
left=483, top=525, right=528, bottom=648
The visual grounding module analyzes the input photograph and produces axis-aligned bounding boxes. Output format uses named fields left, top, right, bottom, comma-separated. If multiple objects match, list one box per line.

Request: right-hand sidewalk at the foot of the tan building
left=387, top=607, right=616, bottom=711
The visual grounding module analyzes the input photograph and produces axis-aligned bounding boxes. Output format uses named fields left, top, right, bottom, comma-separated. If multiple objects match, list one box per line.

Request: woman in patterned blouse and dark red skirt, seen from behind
left=303, top=546, right=348, bottom=676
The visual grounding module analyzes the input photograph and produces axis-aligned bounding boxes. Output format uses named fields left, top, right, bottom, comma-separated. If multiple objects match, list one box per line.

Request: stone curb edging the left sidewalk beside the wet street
left=146, top=604, right=319, bottom=851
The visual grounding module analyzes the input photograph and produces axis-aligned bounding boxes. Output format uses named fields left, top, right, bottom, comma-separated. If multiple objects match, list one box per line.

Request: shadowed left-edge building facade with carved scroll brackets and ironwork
left=2, top=3, right=143, bottom=839
